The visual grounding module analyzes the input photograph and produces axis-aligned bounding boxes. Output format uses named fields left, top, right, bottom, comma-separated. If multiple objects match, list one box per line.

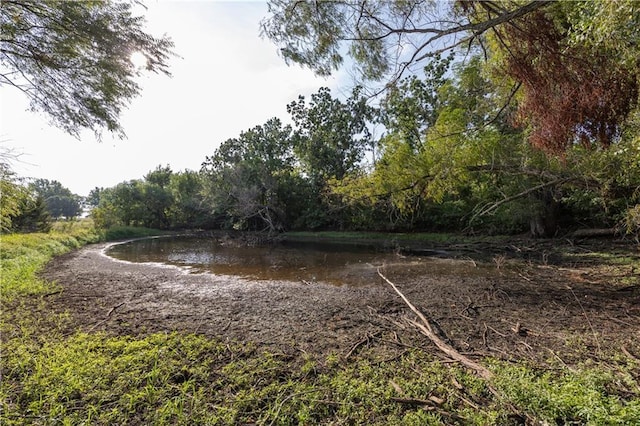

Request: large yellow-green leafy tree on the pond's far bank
left=333, top=56, right=555, bottom=231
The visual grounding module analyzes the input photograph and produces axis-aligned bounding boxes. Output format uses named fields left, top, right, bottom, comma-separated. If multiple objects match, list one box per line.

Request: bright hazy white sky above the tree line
left=0, top=0, right=349, bottom=195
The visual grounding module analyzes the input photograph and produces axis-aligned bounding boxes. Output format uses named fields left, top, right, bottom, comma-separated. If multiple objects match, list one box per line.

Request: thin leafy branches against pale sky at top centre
left=261, top=0, right=551, bottom=81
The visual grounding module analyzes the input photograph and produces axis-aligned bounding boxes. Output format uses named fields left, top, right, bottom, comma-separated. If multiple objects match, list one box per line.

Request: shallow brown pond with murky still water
left=107, top=236, right=458, bottom=285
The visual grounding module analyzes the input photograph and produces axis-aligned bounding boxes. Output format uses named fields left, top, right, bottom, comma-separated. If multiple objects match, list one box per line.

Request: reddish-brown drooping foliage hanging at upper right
left=497, top=12, right=638, bottom=154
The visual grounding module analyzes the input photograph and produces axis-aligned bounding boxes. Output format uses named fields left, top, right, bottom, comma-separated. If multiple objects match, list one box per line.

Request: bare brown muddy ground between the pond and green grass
left=43, top=238, right=640, bottom=363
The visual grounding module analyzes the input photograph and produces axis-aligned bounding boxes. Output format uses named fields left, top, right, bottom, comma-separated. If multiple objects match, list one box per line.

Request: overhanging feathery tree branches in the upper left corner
left=0, top=0, right=173, bottom=137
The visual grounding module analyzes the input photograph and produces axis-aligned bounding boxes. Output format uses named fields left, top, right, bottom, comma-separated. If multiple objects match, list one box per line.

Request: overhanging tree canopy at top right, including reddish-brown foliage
left=262, top=0, right=640, bottom=155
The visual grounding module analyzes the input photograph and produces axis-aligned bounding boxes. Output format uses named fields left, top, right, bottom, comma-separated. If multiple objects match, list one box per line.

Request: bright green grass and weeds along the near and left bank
left=0, top=228, right=640, bottom=425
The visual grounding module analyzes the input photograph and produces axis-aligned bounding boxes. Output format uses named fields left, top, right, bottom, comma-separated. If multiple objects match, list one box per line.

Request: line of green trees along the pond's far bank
left=92, top=68, right=640, bottom=236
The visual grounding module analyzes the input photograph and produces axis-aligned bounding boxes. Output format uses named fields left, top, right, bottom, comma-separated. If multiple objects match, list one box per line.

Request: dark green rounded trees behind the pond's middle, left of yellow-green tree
left=201, top=92, right=373, bottom=232
